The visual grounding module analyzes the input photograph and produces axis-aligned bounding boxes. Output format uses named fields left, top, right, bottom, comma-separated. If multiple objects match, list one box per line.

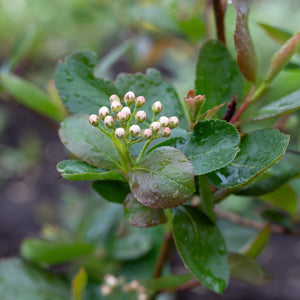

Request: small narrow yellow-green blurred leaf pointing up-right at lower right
left=242, top=225, right=270, bottom=259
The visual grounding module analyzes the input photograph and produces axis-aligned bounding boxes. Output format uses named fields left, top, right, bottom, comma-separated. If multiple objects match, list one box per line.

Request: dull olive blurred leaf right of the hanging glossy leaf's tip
left=228, top=253, right=272, bottom=286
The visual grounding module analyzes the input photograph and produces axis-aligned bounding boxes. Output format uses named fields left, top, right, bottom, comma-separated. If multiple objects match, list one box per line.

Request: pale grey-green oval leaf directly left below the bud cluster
left=59, top=114, right=119, bottom=170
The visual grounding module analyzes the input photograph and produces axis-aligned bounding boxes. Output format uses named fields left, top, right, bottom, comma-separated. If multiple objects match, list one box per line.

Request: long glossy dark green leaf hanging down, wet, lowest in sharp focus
left=173, top=206, right=229, bottom=293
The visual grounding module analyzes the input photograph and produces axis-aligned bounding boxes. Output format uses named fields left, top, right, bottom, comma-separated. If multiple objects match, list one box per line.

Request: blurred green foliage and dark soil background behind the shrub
left=0, top=0, right=300, bottom=300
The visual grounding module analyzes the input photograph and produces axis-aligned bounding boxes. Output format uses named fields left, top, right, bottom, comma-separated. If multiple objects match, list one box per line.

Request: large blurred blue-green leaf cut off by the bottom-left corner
left=0, top=258, right=70, bottom=300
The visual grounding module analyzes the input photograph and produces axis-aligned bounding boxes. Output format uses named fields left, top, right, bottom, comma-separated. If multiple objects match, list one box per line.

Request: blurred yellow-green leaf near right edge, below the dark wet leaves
left=259, top=184, right=298, bottom=215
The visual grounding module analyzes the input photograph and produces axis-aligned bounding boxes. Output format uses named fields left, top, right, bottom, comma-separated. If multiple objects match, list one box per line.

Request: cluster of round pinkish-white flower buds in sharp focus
left=89, top=91, right=179, bottom=141
